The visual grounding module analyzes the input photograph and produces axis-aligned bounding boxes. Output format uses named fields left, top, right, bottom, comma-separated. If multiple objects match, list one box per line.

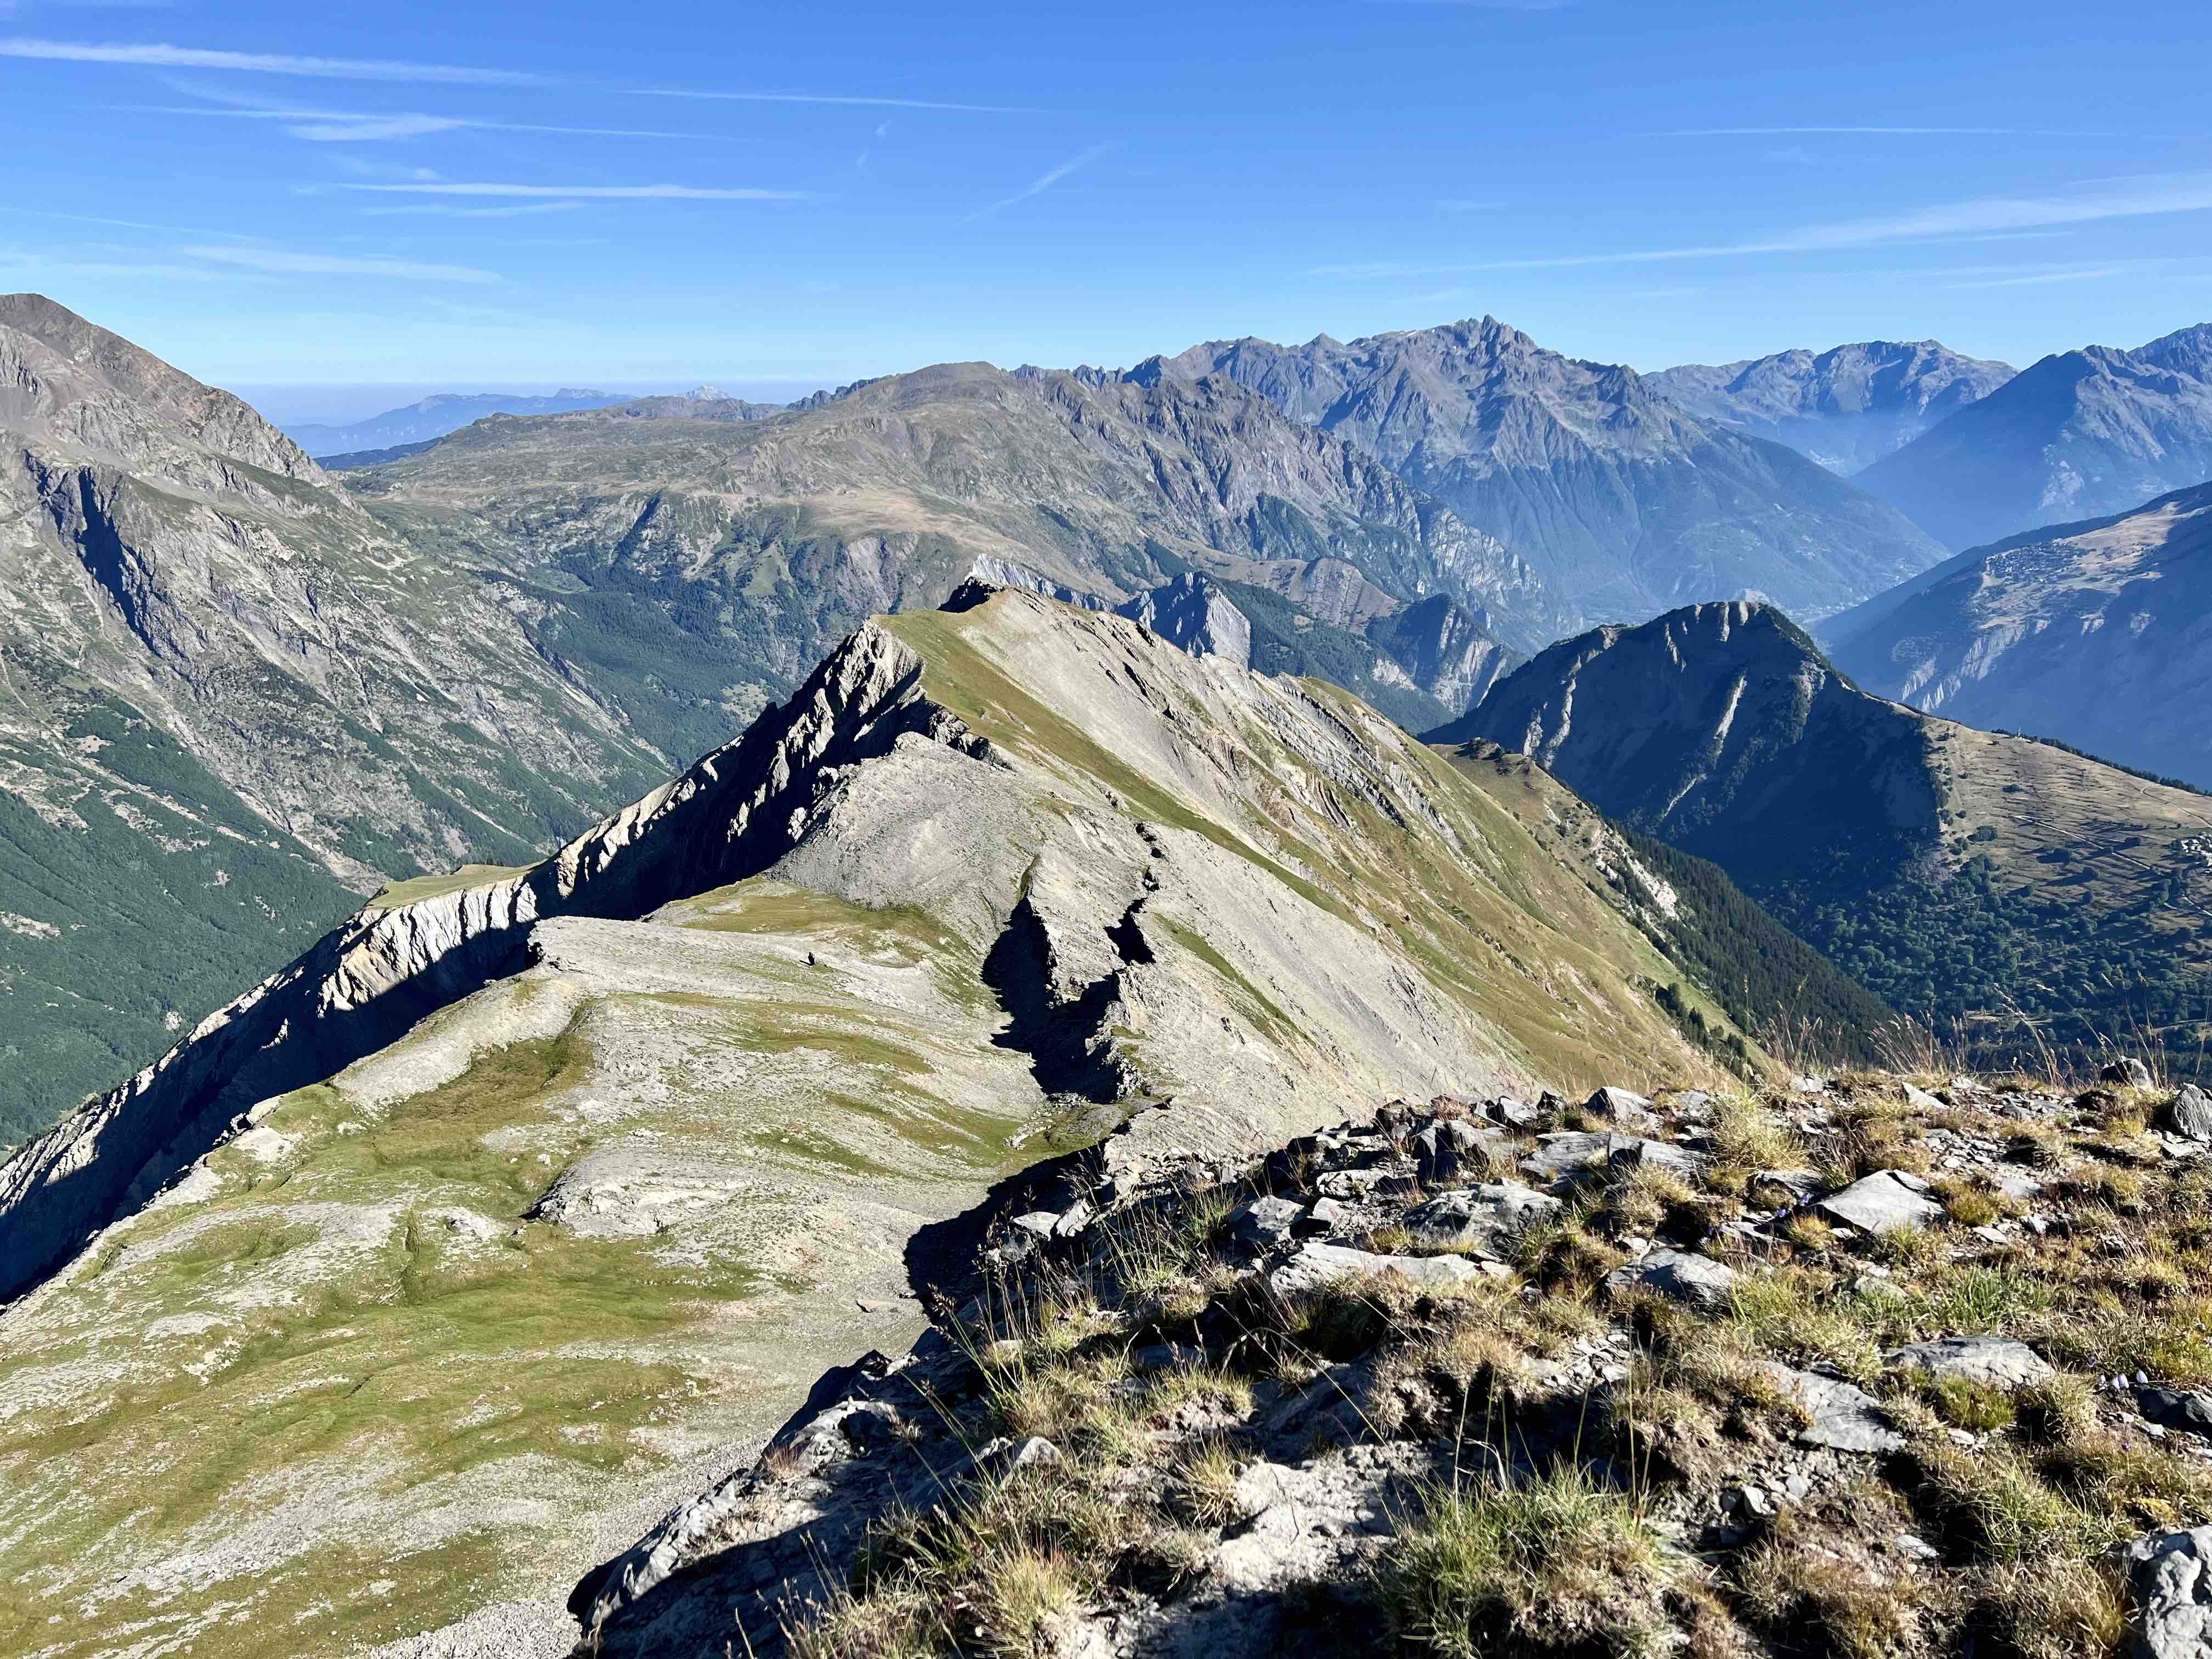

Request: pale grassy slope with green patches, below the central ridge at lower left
left=0, top=883, right=1044, bottom=1659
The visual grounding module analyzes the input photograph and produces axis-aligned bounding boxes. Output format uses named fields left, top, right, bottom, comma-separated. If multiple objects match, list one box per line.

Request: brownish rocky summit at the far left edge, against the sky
left=0, top=294, right=325, bottom=498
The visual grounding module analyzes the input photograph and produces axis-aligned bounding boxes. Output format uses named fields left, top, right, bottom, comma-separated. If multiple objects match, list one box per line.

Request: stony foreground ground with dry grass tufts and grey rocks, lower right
left=571, top=1070, right=2212, bottom=1659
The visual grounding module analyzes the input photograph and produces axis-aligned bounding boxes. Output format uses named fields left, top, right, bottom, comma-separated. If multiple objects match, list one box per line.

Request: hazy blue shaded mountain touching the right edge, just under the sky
left=1858, top=325, right=2212, bottom=549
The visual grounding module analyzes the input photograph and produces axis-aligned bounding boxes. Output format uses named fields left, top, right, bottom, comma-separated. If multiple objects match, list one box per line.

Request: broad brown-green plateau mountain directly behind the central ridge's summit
left=347, top=365, right=1539, bottom=748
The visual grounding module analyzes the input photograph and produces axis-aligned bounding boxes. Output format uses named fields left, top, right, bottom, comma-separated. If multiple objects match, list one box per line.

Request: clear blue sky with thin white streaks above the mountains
left=0, top=0, right=2212, bottom=414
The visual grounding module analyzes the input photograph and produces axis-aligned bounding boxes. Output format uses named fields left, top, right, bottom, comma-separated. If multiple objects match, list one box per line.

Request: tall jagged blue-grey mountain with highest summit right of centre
left=1159, top=319, right=1940, bottom=628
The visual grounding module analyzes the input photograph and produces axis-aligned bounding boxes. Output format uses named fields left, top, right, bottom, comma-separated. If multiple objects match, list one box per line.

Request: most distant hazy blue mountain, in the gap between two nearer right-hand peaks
left=1644, top=341, right=2017, bottom=478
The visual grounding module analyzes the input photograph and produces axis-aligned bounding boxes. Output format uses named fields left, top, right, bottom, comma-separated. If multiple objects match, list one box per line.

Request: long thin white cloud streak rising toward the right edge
left=1307, top=172, right=2212, bottom=276
